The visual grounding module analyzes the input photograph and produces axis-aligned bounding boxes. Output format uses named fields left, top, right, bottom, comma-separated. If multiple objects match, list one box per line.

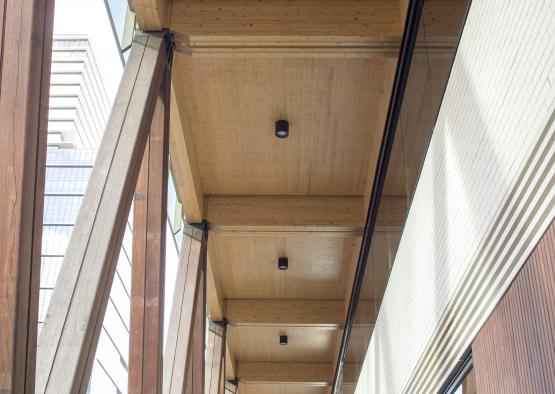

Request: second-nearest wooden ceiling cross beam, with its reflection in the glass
left=206, top=196, right=406, bottom=236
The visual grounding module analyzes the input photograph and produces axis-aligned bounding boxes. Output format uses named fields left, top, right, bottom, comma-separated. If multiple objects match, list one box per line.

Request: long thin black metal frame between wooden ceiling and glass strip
left=332, top=0, right=424, bottom=393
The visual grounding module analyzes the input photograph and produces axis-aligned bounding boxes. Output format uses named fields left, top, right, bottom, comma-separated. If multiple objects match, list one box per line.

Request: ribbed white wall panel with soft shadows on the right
left=356, top=0, right=555, bottom=394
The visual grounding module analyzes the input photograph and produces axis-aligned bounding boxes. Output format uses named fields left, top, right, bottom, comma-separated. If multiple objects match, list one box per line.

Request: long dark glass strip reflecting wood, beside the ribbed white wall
left=335, top=0, right=468, bottom=393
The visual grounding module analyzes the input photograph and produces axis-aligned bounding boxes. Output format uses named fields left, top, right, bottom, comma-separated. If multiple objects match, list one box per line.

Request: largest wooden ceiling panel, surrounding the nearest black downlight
left=174, top=53, right=395, bottom=196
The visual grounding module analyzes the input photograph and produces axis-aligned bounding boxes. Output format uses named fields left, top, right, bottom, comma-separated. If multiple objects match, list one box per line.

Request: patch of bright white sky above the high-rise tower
left=54, top=0, right=126, bottom=101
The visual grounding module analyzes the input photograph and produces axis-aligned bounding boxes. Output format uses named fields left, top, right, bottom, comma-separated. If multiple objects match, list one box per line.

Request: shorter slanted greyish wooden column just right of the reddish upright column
left=163, top=227, right=208, bottom=394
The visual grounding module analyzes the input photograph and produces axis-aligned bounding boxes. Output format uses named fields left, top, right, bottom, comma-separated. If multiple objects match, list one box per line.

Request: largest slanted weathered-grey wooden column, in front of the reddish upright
left=36, top=34, right=168, bottom=394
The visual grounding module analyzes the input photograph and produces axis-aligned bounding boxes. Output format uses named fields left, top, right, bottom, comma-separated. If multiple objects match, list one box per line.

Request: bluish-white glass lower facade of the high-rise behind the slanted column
left=38, top=146, right=132, bottom=393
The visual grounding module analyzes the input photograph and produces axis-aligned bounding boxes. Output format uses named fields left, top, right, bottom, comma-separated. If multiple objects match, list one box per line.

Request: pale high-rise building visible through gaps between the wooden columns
left=38, top=32, right=182, bottom=394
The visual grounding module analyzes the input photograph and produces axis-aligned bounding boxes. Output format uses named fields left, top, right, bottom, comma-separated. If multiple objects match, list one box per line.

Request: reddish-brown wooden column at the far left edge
left=0, top=0, right=54, bottom=393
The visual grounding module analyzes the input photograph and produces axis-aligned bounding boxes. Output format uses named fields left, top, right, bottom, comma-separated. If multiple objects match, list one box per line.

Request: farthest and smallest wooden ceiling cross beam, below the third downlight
left=237, top=361, right=333, bottom=386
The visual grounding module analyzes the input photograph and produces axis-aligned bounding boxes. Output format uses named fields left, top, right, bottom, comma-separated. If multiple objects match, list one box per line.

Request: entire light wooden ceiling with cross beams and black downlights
left=129, top=0, right=470, bottom=394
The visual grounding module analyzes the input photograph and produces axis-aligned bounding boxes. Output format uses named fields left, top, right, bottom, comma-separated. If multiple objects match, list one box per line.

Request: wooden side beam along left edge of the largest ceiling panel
left=170, top=74, right=204, bottom=223
